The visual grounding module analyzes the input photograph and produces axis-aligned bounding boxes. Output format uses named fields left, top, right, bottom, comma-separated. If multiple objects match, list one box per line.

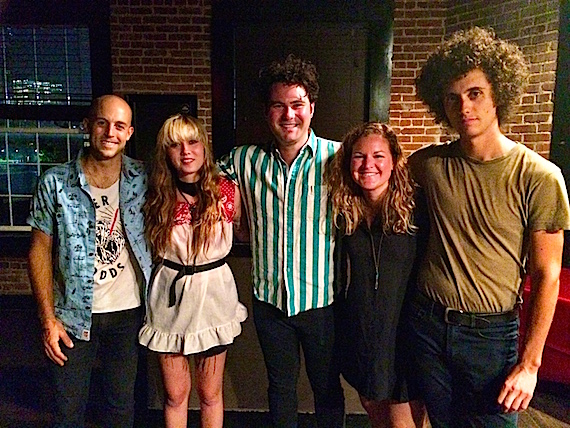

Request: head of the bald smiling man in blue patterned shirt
left=83, top=95, right=133, bottom=160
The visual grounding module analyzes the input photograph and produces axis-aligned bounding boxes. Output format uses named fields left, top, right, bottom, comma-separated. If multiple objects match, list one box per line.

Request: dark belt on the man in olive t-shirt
left=410, top=292, right=519, bottom=328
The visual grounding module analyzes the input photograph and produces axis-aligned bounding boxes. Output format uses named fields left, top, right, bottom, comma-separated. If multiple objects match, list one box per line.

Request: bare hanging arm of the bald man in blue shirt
left=28, top=229, right=73, bottom=366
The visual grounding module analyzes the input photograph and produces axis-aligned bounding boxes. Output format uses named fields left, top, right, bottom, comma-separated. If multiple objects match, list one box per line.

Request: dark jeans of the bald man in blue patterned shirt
left=51, top=308, right=142, bottom=428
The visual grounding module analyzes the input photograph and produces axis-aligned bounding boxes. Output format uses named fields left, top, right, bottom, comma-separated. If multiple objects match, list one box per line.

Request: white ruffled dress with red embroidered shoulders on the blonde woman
left=139, top=179, right=247, bottom=355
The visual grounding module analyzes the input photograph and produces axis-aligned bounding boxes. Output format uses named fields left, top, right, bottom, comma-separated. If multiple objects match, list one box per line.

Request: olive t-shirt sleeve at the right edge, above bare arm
left=529, top=168, right=570, bottom=231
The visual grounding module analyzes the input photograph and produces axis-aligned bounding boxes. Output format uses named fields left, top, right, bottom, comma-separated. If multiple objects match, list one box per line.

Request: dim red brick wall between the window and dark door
left=111, top=0, right=212, bottom=131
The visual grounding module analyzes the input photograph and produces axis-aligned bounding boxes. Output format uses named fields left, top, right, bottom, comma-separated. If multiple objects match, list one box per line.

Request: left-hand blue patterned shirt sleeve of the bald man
left=27, top=174, right=56, bottom=236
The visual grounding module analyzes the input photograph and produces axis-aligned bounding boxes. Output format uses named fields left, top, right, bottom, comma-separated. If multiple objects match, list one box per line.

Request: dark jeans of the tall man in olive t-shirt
left=407, top=295, right=519, bottom=428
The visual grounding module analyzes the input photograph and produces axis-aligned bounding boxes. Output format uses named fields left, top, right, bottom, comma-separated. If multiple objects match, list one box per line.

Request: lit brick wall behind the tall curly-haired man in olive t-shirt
left=390, top=0, right=559, bottom=157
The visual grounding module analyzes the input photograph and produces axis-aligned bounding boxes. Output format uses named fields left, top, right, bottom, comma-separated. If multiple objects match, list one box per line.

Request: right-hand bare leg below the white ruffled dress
left=194, top=351, right=227, bottom=428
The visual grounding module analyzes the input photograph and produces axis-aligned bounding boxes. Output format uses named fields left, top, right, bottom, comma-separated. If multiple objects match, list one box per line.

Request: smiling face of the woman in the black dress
left=350, top=134, right=394, bottom=202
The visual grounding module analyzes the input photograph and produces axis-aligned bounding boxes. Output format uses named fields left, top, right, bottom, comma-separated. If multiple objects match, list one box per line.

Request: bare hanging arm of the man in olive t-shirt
left=498, top=230, right=564, bottom=412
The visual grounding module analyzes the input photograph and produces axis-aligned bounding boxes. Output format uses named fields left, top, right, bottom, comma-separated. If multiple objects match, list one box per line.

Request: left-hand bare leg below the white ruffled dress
left=158, top=354, right=192, bottom=428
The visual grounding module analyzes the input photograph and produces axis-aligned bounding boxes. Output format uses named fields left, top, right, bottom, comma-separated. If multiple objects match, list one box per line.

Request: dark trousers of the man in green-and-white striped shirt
left=253, top=297, right=344, bottom=428
